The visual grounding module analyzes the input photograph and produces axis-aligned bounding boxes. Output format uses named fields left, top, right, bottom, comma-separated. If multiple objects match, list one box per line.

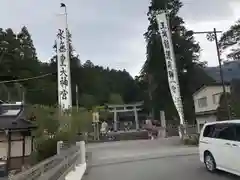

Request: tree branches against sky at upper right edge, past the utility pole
left=219, top=20, right=240, bottom=60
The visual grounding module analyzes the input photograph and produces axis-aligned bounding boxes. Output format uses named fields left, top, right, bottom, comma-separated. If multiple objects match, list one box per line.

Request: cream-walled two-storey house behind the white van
left=193, top=84, right=231, bottom=132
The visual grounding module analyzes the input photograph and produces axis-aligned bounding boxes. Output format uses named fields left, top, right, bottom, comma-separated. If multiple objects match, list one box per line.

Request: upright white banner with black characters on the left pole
left=57, top=14, right=72, bottom=110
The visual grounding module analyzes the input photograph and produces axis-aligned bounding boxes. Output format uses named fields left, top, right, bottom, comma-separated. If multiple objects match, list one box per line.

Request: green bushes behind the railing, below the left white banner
left=25, top=105, right=92, bottom=162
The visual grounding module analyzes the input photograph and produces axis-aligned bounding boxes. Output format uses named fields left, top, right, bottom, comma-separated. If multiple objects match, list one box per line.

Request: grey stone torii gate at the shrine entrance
left=107, top=102, right=143, bottom=131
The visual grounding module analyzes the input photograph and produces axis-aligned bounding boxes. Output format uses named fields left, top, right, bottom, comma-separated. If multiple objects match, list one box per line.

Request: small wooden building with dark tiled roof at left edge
left=0, top=103, right=36, bottom=173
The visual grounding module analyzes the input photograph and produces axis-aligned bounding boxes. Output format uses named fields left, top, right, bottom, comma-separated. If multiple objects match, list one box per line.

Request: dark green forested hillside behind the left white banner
left=0, top=27, right=141, bottom=108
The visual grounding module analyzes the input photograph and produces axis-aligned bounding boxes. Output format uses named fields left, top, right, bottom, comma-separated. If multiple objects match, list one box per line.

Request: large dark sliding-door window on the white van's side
left=213, top=124, right=236, bottom=141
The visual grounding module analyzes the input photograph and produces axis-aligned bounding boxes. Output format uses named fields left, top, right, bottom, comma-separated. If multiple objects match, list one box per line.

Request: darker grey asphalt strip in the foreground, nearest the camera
left=84, top=155, right=240, bottom=180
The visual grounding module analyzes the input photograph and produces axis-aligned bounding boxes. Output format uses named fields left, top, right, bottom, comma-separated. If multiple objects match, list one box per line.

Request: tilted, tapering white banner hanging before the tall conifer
left=157, top=13, right=185, bottom=124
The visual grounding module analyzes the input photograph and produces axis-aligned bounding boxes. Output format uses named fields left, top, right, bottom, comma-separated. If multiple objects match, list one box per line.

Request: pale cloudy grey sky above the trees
left=0, top=0, right=240, bottom=76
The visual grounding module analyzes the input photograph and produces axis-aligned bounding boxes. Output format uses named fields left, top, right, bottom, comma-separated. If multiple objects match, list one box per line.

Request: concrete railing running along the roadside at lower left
left=9, top=142, right=85, bottom=180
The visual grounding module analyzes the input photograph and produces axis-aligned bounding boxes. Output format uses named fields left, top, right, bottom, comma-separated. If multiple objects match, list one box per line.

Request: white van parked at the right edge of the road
left=199, top=120, right=240, bottom=176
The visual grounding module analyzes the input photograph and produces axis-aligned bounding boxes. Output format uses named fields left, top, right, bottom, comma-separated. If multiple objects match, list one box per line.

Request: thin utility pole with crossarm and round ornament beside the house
left=193, top=28, right=231, bottom=120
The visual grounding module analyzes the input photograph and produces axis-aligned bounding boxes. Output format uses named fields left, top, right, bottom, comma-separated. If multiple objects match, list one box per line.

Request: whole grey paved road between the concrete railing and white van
left=84, top=138, right=239, bottom=180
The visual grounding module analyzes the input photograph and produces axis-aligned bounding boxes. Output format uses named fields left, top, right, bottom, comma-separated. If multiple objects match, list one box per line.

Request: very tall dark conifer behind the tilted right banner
left=140, top=0, right=208, bottom=121
